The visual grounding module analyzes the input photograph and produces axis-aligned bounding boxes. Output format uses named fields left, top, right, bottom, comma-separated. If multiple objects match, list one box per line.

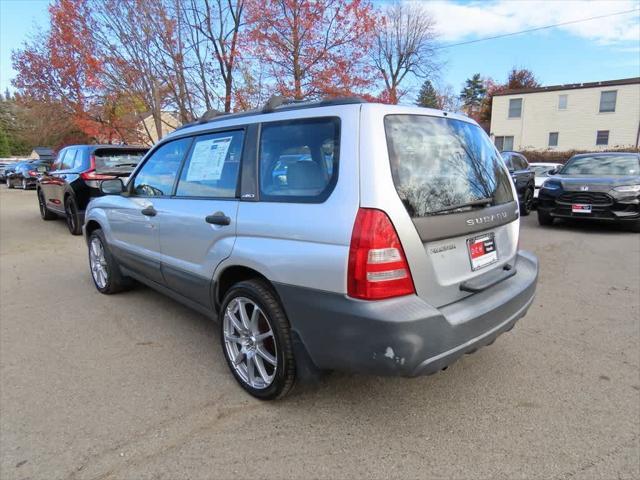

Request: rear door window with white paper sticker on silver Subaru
left=176, top=131, right=244, bottom=198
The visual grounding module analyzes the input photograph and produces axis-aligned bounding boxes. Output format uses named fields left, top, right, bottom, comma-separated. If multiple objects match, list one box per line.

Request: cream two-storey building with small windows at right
left=491, top=77, right=640, bottom=151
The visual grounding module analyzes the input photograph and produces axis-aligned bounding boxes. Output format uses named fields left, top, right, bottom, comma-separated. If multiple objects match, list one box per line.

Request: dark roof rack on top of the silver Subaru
left=176, top=95, right=367, bottom=130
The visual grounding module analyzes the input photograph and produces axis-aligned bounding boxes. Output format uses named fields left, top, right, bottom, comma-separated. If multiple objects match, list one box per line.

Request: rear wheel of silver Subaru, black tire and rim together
left=220, top=279, right=296, bottom=400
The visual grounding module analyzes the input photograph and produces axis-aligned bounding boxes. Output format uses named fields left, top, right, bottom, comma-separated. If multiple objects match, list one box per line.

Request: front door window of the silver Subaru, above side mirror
left=132, top=138, right=191, bottom=197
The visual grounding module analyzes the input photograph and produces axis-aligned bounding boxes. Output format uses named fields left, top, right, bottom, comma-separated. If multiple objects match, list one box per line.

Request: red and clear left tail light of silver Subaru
left=347, top=208, right=415, bottom=300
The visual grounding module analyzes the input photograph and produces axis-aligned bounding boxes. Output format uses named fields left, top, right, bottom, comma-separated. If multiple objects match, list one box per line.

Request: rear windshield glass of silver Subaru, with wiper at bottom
left=385, top=115, right=513, bottom=217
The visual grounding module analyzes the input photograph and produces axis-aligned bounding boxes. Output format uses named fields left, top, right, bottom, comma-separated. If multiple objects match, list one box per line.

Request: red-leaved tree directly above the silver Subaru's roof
left=247, top=0, right=376, bottom=99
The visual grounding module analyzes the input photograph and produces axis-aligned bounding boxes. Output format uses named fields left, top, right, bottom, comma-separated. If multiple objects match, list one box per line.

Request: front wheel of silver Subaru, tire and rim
left=89, top=229, right=131, bottom=295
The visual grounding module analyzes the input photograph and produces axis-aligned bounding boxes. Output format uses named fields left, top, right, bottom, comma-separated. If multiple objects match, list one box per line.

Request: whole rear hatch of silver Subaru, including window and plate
left=384, top=114, right=519, bottom=306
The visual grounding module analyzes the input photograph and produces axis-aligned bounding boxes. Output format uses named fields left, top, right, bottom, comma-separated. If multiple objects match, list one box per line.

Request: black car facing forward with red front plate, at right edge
left=538, top=153, right=640, bottom=232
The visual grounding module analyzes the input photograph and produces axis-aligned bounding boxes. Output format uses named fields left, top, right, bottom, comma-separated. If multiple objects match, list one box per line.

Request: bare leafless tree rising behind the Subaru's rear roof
left=371, top=2, right=439, bottom=104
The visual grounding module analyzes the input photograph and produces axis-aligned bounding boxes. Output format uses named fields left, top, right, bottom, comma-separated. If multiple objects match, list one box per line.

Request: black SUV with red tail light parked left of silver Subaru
left=37, top=145, right=149, bottom=235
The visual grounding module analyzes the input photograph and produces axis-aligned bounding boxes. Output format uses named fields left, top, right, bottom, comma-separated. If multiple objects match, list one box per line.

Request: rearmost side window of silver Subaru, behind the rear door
left=260, top=118, right=340, bottom=202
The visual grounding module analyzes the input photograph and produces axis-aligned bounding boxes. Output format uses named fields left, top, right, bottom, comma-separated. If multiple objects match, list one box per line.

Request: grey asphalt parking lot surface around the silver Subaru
left=0, top=187, right=640, bottom=479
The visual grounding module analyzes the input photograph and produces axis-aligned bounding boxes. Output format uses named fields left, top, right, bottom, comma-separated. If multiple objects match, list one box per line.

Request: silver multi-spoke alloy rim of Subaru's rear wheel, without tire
left=222, top=297, right=278, bottom=389
